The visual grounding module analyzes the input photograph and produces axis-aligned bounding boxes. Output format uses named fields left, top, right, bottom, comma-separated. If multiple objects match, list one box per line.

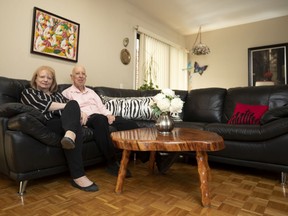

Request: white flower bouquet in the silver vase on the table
left=150, top=89, right=184, bottom=117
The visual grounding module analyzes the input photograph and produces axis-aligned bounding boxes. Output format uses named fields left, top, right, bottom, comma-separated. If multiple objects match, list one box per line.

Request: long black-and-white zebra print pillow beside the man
left=100, top=95, right=153, bottom=120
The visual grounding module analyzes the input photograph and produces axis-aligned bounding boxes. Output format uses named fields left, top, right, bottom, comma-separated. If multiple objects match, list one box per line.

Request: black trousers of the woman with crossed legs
left=47, top=100, right=85, bottom=179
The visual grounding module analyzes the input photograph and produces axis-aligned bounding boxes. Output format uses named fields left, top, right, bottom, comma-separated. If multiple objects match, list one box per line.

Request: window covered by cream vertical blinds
left=135, top=32, right=188, bottom=90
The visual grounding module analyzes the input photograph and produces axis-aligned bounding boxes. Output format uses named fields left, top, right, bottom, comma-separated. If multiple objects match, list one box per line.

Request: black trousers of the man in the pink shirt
left=86, top=114, right=138, bottom=163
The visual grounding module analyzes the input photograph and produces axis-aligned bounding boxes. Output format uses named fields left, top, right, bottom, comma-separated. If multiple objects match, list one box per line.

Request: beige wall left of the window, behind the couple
left=0, top=0, right=185, bottom=88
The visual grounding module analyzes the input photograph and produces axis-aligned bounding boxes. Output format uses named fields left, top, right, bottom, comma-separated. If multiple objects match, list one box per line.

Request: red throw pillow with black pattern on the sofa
left=228, top=103, right=269, bottom=124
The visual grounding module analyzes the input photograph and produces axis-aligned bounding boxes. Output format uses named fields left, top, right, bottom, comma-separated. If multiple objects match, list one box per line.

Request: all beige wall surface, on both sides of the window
left=0, top=0, right=288, bottom=88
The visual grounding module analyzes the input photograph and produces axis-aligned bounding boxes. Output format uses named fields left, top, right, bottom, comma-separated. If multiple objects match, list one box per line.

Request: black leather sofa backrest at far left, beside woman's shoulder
left=0, top=77, right=30, bottom=105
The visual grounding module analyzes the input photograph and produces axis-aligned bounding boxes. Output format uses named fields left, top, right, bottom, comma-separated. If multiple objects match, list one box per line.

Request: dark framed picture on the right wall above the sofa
left=248, top=43, right=288, bottom=86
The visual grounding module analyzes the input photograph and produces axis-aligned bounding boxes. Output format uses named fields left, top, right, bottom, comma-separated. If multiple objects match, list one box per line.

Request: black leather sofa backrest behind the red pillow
left=222, top=85, right=288, bottom=123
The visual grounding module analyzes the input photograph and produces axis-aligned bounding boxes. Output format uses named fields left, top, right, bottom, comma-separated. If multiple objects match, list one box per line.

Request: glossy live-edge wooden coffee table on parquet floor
left=111, top=128, right=224, bottom=207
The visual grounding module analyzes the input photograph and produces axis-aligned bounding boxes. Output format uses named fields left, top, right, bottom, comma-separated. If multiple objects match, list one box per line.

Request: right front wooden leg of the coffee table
left=196, top=151, right=210, bottom=207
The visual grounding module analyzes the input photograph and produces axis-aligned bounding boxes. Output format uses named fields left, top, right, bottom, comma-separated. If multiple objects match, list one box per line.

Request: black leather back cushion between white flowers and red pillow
left=183, top=88, right=226, bottom=123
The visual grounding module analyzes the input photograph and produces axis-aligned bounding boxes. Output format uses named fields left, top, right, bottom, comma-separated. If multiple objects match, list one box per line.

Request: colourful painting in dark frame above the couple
left=30, top=7, right=80, bottom=62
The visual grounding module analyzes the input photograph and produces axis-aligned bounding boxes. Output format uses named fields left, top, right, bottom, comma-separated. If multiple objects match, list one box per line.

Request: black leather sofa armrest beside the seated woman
left=8, top=113, right=61, bottom=147
